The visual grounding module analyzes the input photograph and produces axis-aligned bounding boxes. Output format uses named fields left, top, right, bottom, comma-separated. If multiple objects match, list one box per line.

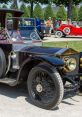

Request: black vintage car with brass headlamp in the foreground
left=0, top=9, right=82, bottom=109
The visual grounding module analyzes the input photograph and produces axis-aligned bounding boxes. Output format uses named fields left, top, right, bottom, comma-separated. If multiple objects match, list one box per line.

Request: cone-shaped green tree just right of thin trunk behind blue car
left=34, top=4, right=44, bottom=19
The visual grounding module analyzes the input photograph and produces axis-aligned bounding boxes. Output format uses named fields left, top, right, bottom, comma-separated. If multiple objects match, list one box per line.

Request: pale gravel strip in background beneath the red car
left=43, top=35, right=82, bottom=42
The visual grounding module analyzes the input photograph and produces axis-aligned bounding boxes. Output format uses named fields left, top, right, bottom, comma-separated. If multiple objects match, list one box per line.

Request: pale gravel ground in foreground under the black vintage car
left=0, top=84, right=82, bottom=117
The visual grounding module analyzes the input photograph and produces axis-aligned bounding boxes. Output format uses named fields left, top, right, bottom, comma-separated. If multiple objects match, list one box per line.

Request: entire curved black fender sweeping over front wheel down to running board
left=15, top=55, right=64, bottom=85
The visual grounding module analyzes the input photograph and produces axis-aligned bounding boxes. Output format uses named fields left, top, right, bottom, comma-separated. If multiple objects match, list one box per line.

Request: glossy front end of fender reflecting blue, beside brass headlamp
left=32, top=55, right=64, bottom=66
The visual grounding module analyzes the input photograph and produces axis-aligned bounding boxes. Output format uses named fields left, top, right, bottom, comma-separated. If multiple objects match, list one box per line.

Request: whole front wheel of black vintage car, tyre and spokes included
left=27, top=65, right=64, bottom=109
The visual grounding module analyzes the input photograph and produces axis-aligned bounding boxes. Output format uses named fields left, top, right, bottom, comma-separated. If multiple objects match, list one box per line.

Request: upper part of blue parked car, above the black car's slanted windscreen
left=19, top=17, right=44, bottom=40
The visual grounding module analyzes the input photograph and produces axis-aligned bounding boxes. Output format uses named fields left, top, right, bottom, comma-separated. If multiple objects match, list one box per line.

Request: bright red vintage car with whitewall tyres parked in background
left=55, top=23, right=82, bottom=38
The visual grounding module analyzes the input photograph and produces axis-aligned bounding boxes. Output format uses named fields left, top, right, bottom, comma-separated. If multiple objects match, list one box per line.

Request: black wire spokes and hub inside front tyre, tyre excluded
left=32, top=71, right=55, bottom=104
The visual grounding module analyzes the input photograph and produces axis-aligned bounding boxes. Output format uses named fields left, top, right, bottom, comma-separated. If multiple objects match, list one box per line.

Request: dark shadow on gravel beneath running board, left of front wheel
left=0, top=84, right=28, bottom=98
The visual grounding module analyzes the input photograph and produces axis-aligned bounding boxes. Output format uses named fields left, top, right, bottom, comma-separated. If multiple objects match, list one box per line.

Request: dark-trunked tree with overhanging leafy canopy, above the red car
left=53, top=0, right=82, bottom=19
